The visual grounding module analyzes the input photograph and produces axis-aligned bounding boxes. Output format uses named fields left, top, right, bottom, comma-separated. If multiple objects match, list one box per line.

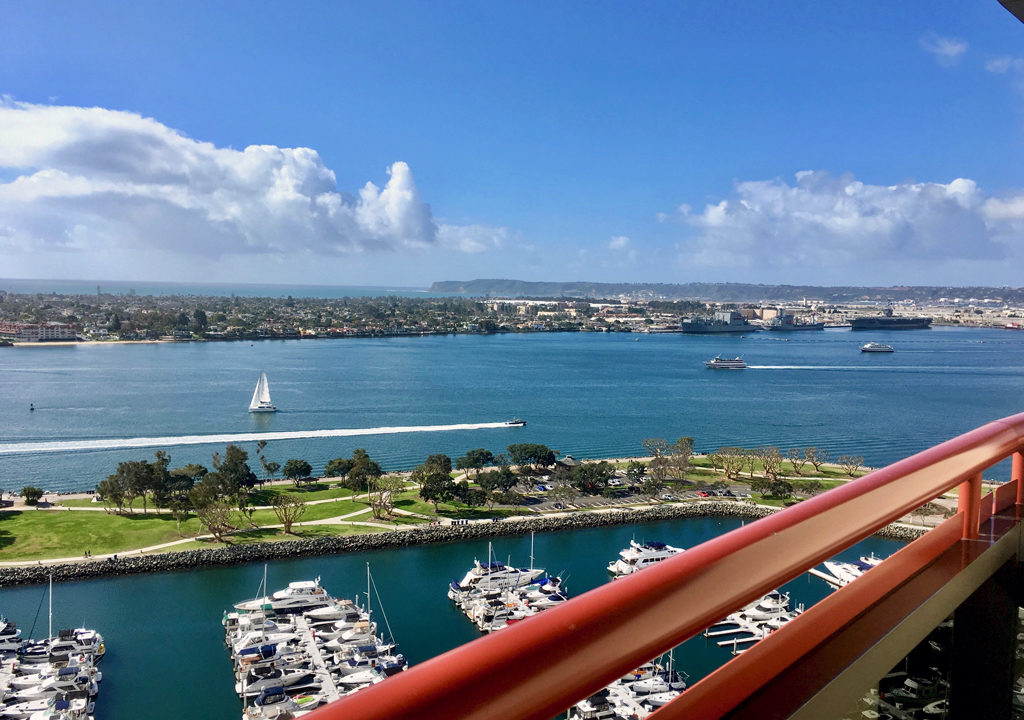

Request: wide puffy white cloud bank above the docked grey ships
left=677, top=171, right=1024, bottom=271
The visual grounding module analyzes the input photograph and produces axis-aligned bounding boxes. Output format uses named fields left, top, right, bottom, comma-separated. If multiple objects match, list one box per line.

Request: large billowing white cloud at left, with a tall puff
left=0, top=97, right=502, bottom=257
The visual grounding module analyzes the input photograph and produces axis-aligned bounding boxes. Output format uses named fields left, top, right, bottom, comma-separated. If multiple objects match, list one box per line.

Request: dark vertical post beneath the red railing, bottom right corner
left=949, top=560, right=1017, bottom=720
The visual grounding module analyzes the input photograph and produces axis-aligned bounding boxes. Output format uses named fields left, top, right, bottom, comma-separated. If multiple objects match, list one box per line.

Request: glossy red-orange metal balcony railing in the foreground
left=308, top=414, right=1024, bottom=720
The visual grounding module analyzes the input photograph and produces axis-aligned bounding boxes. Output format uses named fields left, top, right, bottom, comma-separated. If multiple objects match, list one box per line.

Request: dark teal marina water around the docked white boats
left=0, top=519, right=898, bottom=720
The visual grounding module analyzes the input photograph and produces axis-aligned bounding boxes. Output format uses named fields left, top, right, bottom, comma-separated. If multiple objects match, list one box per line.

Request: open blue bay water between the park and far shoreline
left=0, top=328, right=1024, bottom=491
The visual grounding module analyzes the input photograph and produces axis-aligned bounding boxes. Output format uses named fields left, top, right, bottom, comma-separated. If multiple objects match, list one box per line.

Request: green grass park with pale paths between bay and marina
left=0, top=456, right=880, bottom=563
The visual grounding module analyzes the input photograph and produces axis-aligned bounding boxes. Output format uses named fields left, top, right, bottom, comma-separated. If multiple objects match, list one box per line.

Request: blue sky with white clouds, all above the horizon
left=0, top=0, right=1024, bottom=286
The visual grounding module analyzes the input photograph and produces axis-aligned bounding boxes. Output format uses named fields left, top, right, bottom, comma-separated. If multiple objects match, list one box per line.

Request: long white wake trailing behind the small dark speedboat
left=0, top=422, right=509, bottom=455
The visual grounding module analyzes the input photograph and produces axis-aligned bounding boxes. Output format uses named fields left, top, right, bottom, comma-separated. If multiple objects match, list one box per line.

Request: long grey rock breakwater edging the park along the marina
left=0, top=502, right=924, bottom=587
